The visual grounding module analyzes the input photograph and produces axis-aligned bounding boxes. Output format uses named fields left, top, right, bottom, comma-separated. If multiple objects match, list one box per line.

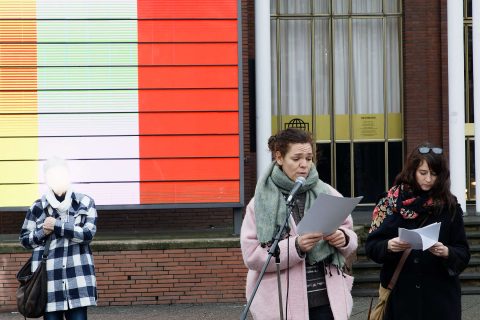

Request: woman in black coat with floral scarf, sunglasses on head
left=365, top=143, right=470, bottom=320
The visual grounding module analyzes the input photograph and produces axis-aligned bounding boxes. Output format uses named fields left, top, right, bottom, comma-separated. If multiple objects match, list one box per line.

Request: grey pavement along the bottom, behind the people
left=0, top=295, right=480, bottom=320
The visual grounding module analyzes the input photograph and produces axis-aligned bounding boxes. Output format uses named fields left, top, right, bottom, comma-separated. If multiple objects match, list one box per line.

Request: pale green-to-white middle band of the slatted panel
left=37, top=0, right=140, bottom=204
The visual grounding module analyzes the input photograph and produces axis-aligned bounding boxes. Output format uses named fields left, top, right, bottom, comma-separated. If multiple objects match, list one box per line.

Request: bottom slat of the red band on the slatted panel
left=140, top=181, right=240, bottom=204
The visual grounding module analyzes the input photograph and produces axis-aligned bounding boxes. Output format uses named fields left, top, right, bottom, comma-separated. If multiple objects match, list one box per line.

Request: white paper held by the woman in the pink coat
left=297, top=193, right=363, bottom=235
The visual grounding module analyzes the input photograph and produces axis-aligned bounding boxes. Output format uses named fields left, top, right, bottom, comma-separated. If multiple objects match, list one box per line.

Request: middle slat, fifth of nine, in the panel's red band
left=138, top=89, right=238, bottom=111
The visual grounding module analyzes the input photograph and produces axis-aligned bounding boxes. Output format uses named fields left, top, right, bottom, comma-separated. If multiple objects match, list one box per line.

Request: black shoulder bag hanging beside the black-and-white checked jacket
left=17, top=228, right=52, bottom=318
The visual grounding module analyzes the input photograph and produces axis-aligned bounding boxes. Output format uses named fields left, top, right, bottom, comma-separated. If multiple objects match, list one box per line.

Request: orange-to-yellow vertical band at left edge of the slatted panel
left=0, top=0, right=38, bottom=207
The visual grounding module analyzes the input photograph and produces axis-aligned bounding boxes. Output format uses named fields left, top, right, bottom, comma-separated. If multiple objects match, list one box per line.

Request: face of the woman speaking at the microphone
left=275, top=143, right=313, bottom=181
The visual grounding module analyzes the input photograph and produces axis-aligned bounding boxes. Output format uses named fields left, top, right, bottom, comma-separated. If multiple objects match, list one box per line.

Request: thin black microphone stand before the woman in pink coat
left=240, top=199, right=294, bottom=320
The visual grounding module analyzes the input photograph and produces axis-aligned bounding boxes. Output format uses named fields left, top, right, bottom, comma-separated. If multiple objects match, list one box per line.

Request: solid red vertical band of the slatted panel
left=138, top=0, right=240, bottom=203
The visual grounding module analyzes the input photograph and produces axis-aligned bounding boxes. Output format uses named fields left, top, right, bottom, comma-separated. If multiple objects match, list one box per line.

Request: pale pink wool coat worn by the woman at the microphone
left=240, top=188, right=357, bottom=320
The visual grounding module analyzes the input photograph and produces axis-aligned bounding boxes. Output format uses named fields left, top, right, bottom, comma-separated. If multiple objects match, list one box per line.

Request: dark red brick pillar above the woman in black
left=403, top=0, right=448, bottom=154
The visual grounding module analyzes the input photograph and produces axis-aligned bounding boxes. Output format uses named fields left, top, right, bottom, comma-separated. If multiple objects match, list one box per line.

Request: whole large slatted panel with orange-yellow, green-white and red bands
left=0, top=0, right=241, bottom=207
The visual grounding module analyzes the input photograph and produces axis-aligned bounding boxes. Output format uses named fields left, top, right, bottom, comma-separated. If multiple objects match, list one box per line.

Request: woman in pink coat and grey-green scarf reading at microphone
left=240, top=128, right=357, bottom=320
